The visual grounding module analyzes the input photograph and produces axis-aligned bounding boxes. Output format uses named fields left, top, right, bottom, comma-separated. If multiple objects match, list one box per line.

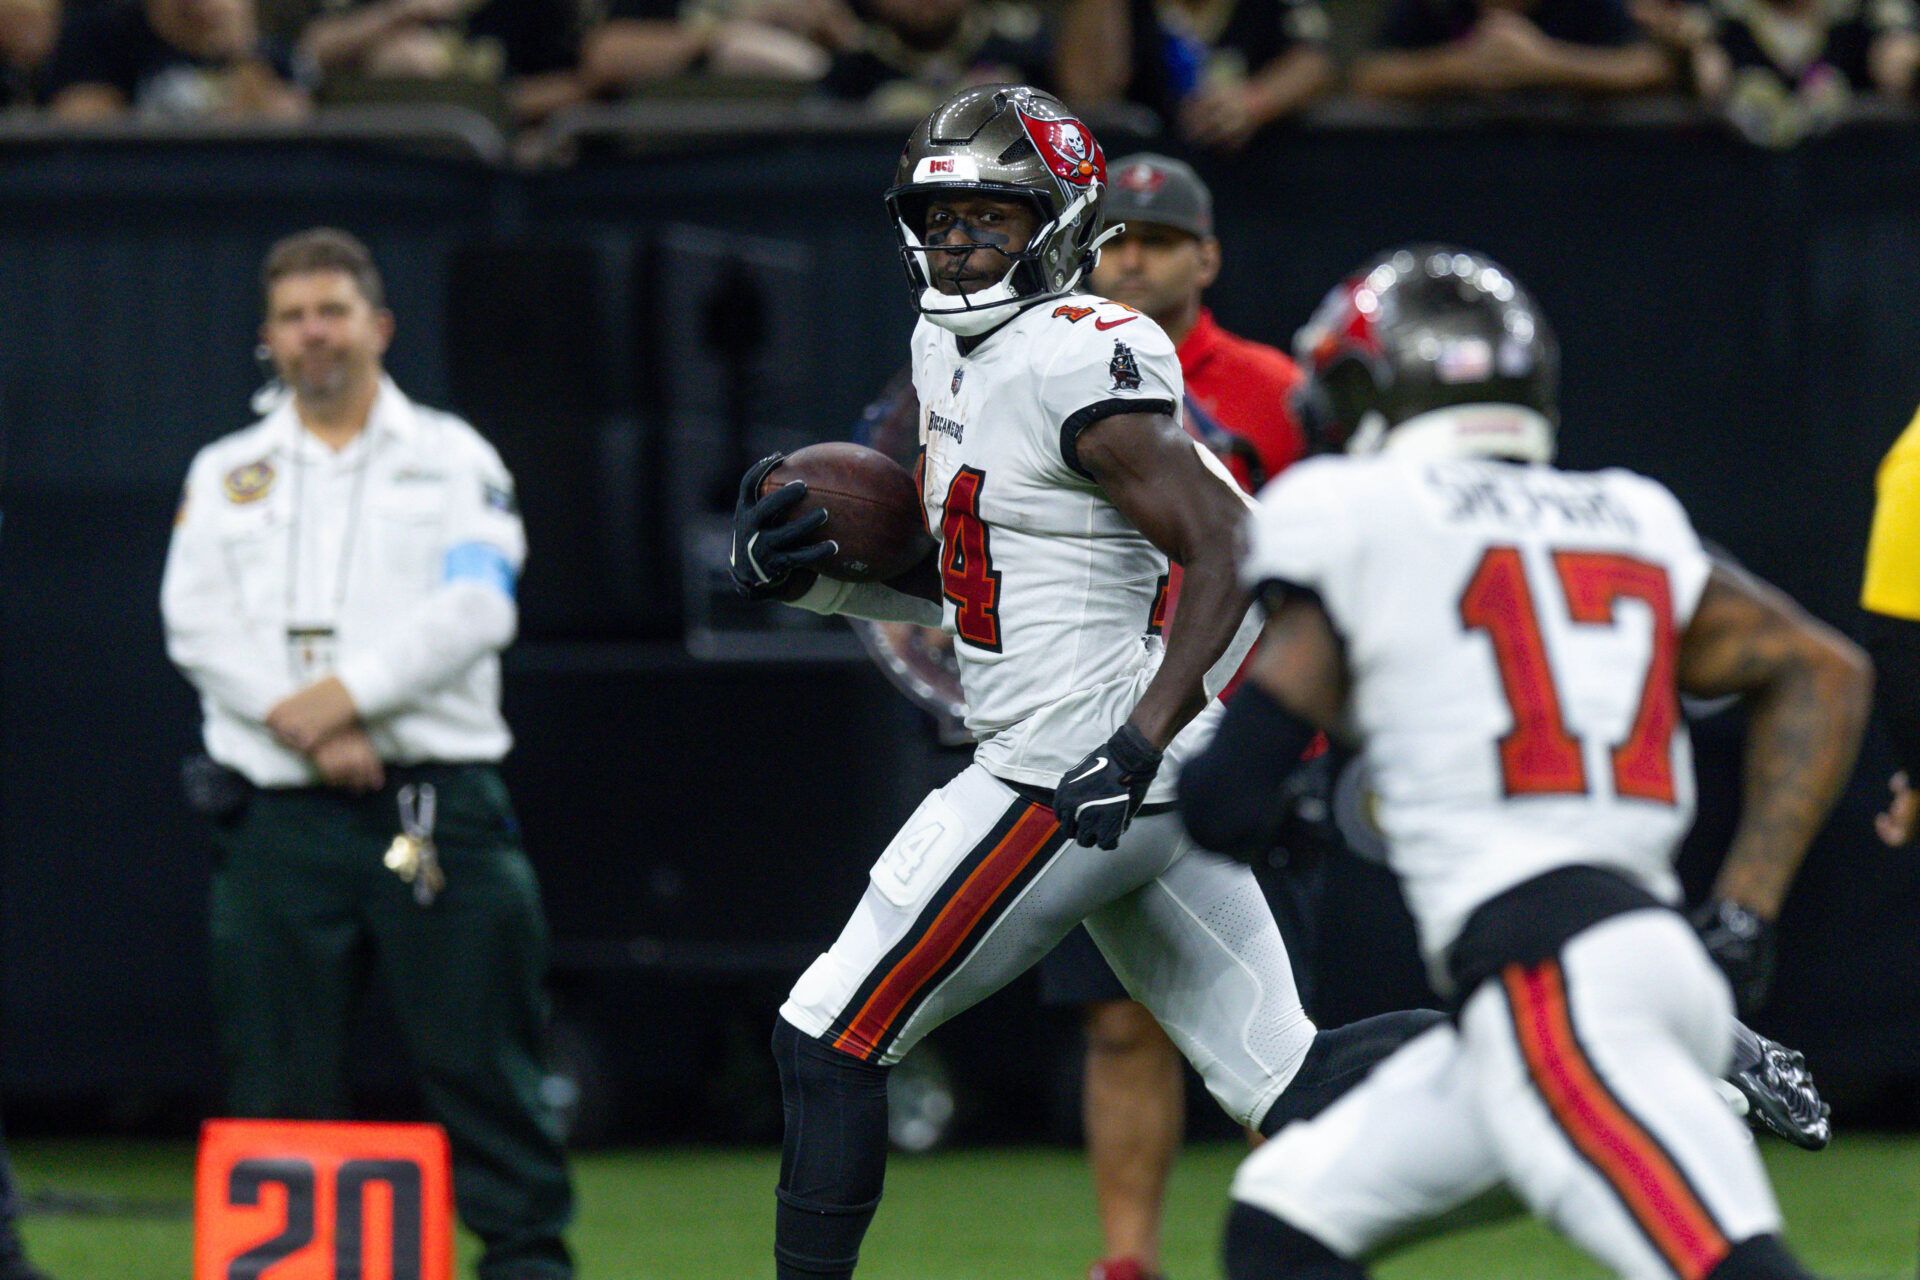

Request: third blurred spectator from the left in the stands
left=300, top=0, right=588, bottom=121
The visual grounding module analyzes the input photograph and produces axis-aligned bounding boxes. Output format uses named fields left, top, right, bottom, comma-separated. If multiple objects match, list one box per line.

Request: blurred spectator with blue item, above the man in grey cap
left=1056, top=0, right=1334, bottom=150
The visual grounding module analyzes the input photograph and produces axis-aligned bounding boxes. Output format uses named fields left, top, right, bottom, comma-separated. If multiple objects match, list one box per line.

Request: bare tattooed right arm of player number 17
left=1680, top=562, right=1874, bottom=919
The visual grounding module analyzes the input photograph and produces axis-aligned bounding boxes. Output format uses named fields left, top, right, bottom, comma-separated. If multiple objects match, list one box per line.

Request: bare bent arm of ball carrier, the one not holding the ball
left=1075, top=413, right=1248, bottom=748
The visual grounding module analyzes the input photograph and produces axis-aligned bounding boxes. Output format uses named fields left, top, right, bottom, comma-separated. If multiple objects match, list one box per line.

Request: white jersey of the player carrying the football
left=912, top=296, right=1256, bottom=802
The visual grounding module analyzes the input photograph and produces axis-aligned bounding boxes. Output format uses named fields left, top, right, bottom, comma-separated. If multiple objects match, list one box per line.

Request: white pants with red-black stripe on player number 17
left=1233, top=910, right=1780, bottom=1280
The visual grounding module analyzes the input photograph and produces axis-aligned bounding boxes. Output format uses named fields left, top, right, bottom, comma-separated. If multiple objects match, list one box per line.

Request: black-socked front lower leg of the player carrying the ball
left=774, top=1017, right=887, bottom=1280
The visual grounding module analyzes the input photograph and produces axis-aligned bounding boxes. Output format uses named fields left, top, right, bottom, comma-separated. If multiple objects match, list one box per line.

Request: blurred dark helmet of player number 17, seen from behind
left=1294, top=244, right=1559, bottom=462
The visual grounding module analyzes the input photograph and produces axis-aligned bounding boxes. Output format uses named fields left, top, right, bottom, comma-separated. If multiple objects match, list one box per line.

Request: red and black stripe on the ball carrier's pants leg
left=822, top=800, right=1066, bottom=1061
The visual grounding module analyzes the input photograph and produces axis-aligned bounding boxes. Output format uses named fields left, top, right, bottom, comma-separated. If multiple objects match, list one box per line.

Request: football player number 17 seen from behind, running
left=1181, top=246, right=1872, bottom=1280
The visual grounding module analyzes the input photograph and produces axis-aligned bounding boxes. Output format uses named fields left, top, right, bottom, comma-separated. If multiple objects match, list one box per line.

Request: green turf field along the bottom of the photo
left=15, top=1136, right=1920, bottom=1280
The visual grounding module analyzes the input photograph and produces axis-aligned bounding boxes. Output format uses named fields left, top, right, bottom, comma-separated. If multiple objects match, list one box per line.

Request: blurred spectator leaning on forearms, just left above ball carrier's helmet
left=580, top=0, right=860, bottom=96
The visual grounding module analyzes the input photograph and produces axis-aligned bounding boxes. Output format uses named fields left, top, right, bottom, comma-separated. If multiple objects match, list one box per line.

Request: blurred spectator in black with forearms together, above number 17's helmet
left=1352, top=0, right=1676, bottom=98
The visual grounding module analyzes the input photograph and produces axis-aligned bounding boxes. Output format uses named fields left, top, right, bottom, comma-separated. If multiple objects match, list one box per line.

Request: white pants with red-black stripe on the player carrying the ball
left=780, top=764, right=1313, bottom=1126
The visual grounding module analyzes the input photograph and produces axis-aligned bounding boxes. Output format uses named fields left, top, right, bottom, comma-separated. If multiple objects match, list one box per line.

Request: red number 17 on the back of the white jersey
left=1459, top=547, right=1680, bottom=804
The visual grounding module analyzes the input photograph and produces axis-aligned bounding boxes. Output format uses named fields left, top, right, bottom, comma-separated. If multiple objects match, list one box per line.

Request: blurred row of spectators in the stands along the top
left=0, top=0, right=1920, bottom=152
